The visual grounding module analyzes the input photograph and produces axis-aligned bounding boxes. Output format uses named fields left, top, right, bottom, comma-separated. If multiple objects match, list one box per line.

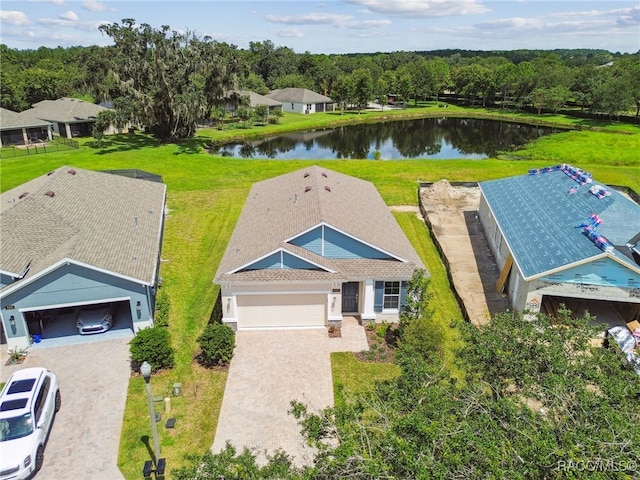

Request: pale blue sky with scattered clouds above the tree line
left=0, top=0, right=640, bottom=54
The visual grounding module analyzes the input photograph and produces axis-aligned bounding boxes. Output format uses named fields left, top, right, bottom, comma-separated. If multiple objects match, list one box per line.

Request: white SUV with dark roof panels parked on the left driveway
left=0, top=367, right=61, bottom=480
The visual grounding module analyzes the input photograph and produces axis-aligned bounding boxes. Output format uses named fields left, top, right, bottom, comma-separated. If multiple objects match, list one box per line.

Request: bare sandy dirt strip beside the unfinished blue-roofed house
left=420, top=180, right=509, bottom=324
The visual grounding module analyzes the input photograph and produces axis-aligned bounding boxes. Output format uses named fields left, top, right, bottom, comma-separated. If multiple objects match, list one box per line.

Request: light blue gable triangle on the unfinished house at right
left=541, top=258, right=640, bottom=288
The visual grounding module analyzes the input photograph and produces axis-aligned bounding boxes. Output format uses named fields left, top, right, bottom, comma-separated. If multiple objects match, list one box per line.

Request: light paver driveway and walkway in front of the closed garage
left=212, top=318, right=368, bottom=466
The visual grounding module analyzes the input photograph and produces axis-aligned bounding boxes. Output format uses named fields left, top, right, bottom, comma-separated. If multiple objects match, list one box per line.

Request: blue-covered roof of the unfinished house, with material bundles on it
left=480, top=166, right=640, bottom=278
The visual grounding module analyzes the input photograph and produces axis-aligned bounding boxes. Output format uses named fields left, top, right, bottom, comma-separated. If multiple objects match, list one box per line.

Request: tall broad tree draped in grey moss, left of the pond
left=100, top=19, right=242, bottom=141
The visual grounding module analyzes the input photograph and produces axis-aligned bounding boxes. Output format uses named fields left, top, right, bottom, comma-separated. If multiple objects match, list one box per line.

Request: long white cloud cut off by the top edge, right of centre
left=343, top=0, right=490, bottom=18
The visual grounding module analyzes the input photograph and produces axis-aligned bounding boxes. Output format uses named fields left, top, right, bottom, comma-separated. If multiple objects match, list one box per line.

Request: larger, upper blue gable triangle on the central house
left=290, top=226, right=392, bottom=259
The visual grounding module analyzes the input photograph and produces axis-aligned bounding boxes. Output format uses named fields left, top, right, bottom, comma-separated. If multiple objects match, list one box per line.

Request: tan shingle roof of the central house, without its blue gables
left=216, top=166, right=424, bottom=282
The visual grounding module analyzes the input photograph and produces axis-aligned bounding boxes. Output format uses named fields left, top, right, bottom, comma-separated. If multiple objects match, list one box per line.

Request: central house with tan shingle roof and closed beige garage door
left=214, top=166, right=425, bottom=329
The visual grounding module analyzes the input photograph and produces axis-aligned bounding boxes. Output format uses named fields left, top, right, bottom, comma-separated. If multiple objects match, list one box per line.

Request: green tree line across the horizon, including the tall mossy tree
left=0, top=19, right=640, bottom=139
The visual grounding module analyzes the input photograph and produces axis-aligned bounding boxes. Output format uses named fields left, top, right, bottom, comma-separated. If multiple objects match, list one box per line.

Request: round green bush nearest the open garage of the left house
left=129, top=327, right=174, bottom=371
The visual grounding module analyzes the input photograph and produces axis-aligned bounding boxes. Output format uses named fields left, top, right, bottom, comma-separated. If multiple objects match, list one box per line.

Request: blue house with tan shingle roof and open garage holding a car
left=0, top=166, right=166, bottom=348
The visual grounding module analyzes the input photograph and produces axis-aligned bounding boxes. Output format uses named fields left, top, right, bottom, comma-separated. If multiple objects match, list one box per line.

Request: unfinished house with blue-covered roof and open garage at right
left=478, top=164, right=640, bottom=324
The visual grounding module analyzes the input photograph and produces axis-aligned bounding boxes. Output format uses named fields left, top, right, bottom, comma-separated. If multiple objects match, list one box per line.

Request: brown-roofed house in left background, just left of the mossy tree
left=23, top=98, right=118, bottom=138
